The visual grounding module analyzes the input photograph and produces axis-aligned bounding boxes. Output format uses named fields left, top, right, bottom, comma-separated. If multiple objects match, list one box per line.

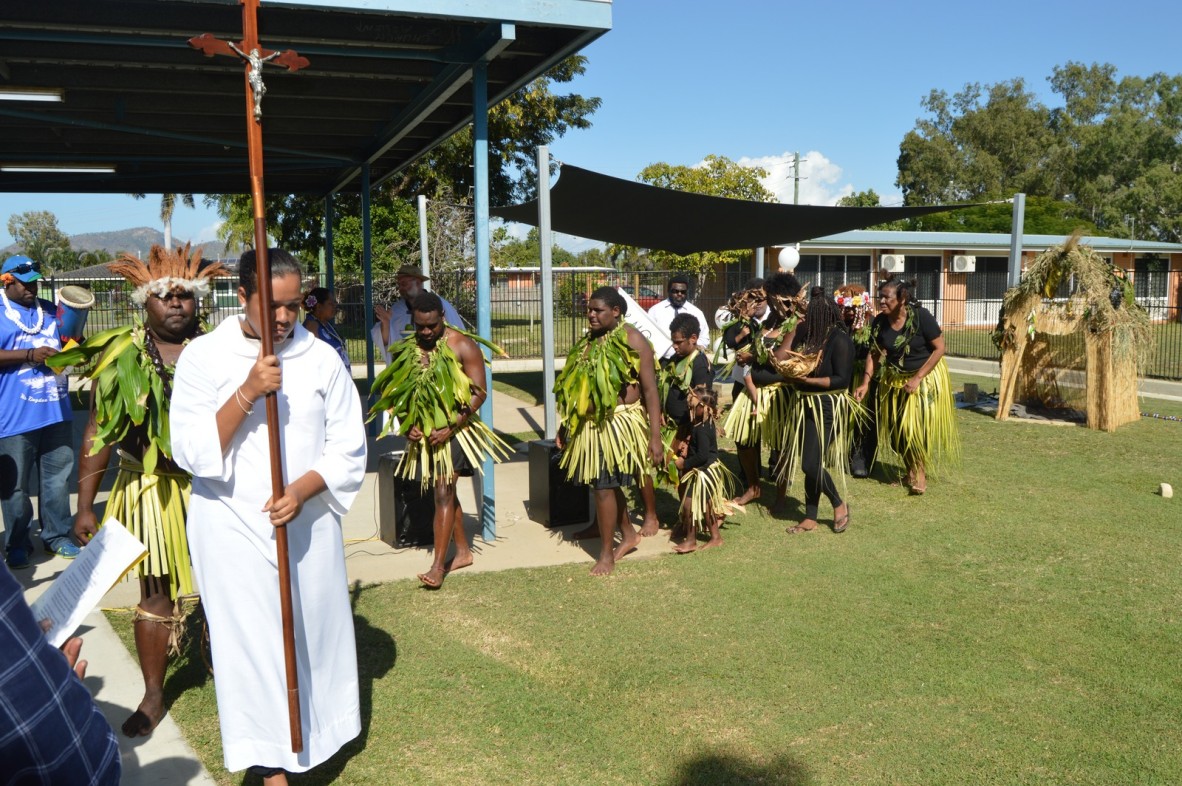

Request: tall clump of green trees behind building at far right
left=896, top=63, right=1182, bottom=242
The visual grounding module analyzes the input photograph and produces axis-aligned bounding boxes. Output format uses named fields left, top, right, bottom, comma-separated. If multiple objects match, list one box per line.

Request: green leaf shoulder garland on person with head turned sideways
left=554, top=323, right=641, bottom=431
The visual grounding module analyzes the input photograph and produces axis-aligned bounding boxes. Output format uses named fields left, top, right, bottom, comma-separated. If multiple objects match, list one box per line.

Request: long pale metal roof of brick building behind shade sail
left=800, top=229, right=1182, bottom=254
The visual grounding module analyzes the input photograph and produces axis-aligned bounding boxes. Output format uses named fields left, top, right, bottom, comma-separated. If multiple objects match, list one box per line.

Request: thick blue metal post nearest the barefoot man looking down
left=472, top=63, right=496, bottom=540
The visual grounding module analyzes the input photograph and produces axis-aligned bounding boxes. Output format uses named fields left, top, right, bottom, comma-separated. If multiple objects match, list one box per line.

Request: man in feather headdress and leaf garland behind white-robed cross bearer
left=51, top=246, right=227, bottom=736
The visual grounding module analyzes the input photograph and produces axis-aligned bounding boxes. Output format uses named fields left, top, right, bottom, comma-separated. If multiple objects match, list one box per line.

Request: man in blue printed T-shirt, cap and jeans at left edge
left=0, top=255, right=78, bottom=569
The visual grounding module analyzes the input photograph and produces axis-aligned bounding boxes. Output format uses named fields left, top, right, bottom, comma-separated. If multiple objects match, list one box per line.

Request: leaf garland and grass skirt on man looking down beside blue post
left=369, top=325, right=509, bottom=487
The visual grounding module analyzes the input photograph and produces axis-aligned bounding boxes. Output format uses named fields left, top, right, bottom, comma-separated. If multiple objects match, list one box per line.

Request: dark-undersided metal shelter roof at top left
left=0, top=0, right=611, bottom=195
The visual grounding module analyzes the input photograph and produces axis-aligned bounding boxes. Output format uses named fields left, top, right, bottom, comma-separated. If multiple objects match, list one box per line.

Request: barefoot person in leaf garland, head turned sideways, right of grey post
left=554, top=286, right=664, bottom=576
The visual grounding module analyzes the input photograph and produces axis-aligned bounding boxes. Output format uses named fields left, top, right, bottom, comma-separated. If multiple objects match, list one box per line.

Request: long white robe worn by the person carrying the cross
left=170, top=318, right=365, bottom=772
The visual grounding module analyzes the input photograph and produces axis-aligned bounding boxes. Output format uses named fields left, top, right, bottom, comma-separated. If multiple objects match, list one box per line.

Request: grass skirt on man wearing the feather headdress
left=106, top=450, right=194, bottom=600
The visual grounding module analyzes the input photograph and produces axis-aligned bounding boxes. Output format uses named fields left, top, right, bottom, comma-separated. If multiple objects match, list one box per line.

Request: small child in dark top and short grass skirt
left=674, top=385, right=738, bottom=554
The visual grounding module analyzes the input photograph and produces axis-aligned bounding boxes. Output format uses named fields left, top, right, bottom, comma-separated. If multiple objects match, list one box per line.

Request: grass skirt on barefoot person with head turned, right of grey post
left=558, top=401, right=649, bottom=485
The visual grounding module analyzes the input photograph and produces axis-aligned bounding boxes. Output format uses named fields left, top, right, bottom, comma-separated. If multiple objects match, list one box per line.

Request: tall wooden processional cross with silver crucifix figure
left=189, top=0, right=309, bottom=753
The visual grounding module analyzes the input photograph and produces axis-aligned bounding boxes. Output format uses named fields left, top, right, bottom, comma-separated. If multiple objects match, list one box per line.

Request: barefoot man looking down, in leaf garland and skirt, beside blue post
left=370, top=292, right=509, bottom=590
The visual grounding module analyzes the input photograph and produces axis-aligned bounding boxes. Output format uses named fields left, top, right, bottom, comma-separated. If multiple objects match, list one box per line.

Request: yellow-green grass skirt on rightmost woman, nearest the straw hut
left=876, top=358, right=961, bottom=472
